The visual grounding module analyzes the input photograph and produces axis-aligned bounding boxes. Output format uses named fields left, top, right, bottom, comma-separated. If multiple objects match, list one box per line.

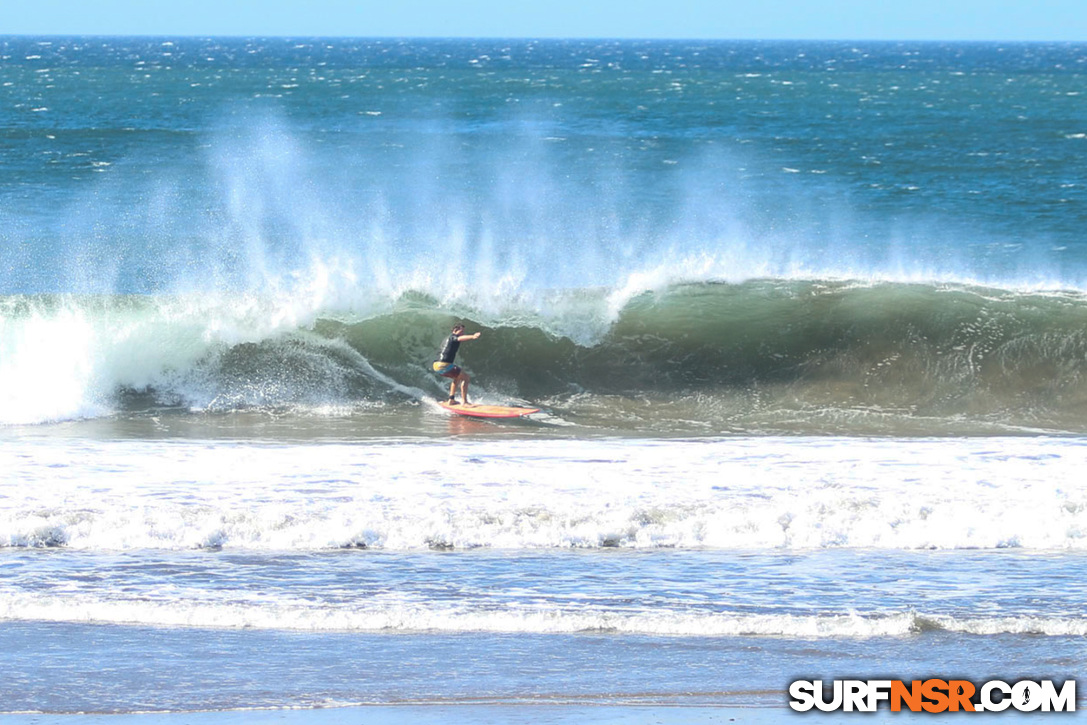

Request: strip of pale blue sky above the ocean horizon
left=0, top=0, right=1087, bottom=40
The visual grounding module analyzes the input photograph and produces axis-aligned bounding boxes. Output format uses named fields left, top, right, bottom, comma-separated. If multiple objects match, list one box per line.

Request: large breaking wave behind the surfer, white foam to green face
left=6, top=279, right=1087, bottom=435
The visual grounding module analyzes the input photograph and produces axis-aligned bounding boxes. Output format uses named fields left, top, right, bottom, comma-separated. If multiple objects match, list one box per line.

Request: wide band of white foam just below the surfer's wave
left=0, top=438, right=1087, bottom=551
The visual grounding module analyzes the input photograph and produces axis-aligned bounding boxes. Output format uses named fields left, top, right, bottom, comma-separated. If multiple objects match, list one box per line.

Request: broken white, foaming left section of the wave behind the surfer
left=0, top=288, right=404, bottom=425
